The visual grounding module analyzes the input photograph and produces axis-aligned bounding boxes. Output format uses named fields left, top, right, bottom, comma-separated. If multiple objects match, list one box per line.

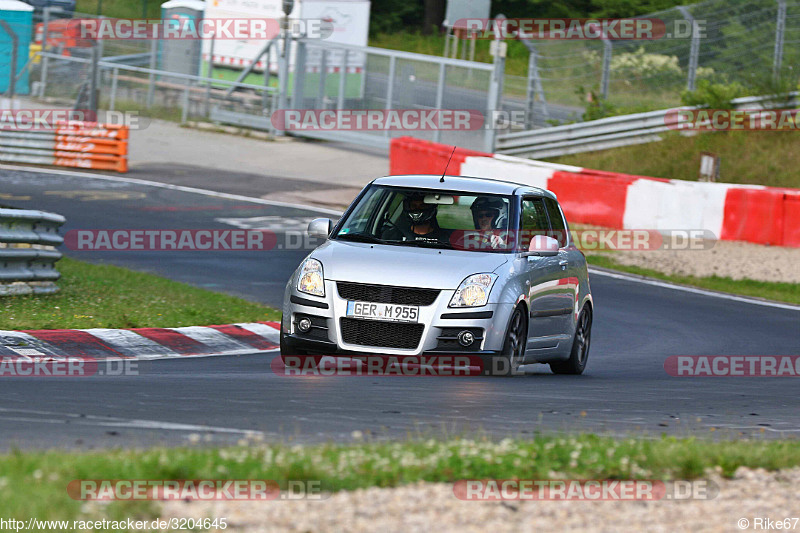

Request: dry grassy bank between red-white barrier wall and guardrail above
left=548, top=131, right=800, bottom=188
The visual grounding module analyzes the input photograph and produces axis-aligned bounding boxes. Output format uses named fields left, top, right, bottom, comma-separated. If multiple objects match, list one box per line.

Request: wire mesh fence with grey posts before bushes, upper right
left=524, top=0, right=800, bottom=121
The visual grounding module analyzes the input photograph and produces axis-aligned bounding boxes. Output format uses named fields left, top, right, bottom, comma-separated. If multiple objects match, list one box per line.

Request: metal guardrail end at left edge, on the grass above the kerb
left=0, top=209, right=66, bottom=296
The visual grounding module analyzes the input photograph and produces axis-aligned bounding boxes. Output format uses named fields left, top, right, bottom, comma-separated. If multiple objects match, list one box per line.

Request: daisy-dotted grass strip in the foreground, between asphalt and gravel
left=0, top=435, right=800, bottom=520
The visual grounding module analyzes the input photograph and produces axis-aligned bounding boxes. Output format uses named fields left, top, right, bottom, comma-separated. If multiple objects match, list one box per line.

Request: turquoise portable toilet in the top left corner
left=0, top=0, right=33, bottom=94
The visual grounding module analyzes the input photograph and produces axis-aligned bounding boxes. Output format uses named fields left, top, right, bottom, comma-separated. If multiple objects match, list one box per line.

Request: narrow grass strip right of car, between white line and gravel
left=586, top=254, right=800, bottom=304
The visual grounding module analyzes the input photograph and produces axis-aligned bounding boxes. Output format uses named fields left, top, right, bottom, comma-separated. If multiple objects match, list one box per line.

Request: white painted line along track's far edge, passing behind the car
left=0, top=164, right=800, bottom=311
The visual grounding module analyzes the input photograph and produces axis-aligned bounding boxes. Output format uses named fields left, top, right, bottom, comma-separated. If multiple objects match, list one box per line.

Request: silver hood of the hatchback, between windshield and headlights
left=311, top=241, right=509, bottom=289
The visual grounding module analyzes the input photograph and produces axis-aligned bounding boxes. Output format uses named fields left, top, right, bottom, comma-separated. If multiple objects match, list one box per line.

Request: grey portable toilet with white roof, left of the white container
left=158, top=0, right=206, bottom=76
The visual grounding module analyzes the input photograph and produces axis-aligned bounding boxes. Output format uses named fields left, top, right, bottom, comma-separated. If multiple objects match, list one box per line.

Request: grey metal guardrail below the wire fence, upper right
left=497, top=93, right=798, bottom=158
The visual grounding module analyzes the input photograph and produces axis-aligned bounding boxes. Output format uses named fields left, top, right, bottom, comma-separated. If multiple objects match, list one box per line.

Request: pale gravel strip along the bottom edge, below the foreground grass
left=162, top=468, right=800, bottom=533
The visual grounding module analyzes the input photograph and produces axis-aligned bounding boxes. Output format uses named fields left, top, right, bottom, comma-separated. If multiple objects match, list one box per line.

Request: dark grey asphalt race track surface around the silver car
left=0, top=169, right=800, bottom=449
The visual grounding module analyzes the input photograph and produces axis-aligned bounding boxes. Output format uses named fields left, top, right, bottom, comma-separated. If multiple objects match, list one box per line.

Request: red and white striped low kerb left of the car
left=0, top=322, right=280, bottom=360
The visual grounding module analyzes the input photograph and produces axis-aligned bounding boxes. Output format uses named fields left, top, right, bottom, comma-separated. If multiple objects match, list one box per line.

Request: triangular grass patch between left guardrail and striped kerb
left=0, top=257, right=280, bottom=330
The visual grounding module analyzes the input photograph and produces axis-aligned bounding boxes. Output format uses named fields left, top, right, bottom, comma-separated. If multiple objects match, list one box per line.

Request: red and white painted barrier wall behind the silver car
left=390, top=137, right=800, bottom=247
